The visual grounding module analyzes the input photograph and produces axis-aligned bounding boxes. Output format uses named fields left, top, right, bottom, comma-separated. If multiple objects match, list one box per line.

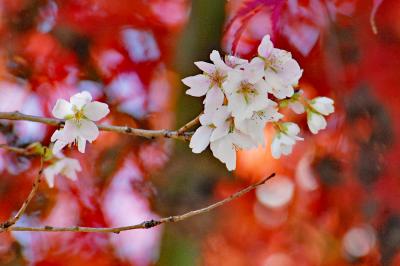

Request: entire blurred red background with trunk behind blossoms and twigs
left=0, top=0, right=400, bottom=266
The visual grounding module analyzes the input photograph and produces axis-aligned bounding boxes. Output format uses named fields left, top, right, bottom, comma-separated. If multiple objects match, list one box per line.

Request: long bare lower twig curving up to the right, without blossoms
left=4, top=173, right=275, bottom=234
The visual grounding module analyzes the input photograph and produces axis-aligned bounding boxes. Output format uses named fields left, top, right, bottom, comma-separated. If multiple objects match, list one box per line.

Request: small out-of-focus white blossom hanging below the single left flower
left=43, top=154, right=82, bottom=188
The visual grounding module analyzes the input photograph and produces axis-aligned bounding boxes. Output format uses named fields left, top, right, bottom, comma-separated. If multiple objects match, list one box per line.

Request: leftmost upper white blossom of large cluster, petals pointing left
left=182, top=50, right=232, bottom=109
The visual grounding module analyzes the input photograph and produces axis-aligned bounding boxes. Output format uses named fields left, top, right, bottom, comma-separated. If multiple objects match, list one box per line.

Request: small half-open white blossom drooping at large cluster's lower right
left=271, top=122, right=303, bottom=159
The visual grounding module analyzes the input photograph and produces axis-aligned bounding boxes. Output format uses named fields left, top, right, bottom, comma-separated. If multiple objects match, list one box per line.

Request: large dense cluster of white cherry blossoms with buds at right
left=182, top=35, right=334, bottom=170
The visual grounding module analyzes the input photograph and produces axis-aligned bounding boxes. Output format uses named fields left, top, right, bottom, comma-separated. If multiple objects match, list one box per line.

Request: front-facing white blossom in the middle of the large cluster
left=225, top=65, right=268, bottom=120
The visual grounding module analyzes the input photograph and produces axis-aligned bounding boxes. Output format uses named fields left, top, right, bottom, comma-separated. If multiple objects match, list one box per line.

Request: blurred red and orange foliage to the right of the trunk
left=203, top=0, right=400, bottom=266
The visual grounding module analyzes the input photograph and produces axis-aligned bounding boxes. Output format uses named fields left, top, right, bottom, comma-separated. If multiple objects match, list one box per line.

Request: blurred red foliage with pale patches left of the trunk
left=0, top=0, right=189, bottom=265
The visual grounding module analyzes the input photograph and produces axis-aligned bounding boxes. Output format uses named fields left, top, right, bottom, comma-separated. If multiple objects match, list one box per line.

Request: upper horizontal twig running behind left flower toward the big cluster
left=0, top=111, right=192, bottom=140
